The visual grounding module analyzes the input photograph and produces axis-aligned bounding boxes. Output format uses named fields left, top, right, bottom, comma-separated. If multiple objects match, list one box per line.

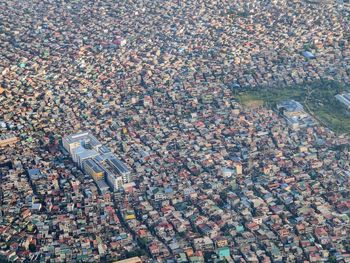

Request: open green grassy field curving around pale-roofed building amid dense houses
left=237, top=81, right=350, bottom=133
